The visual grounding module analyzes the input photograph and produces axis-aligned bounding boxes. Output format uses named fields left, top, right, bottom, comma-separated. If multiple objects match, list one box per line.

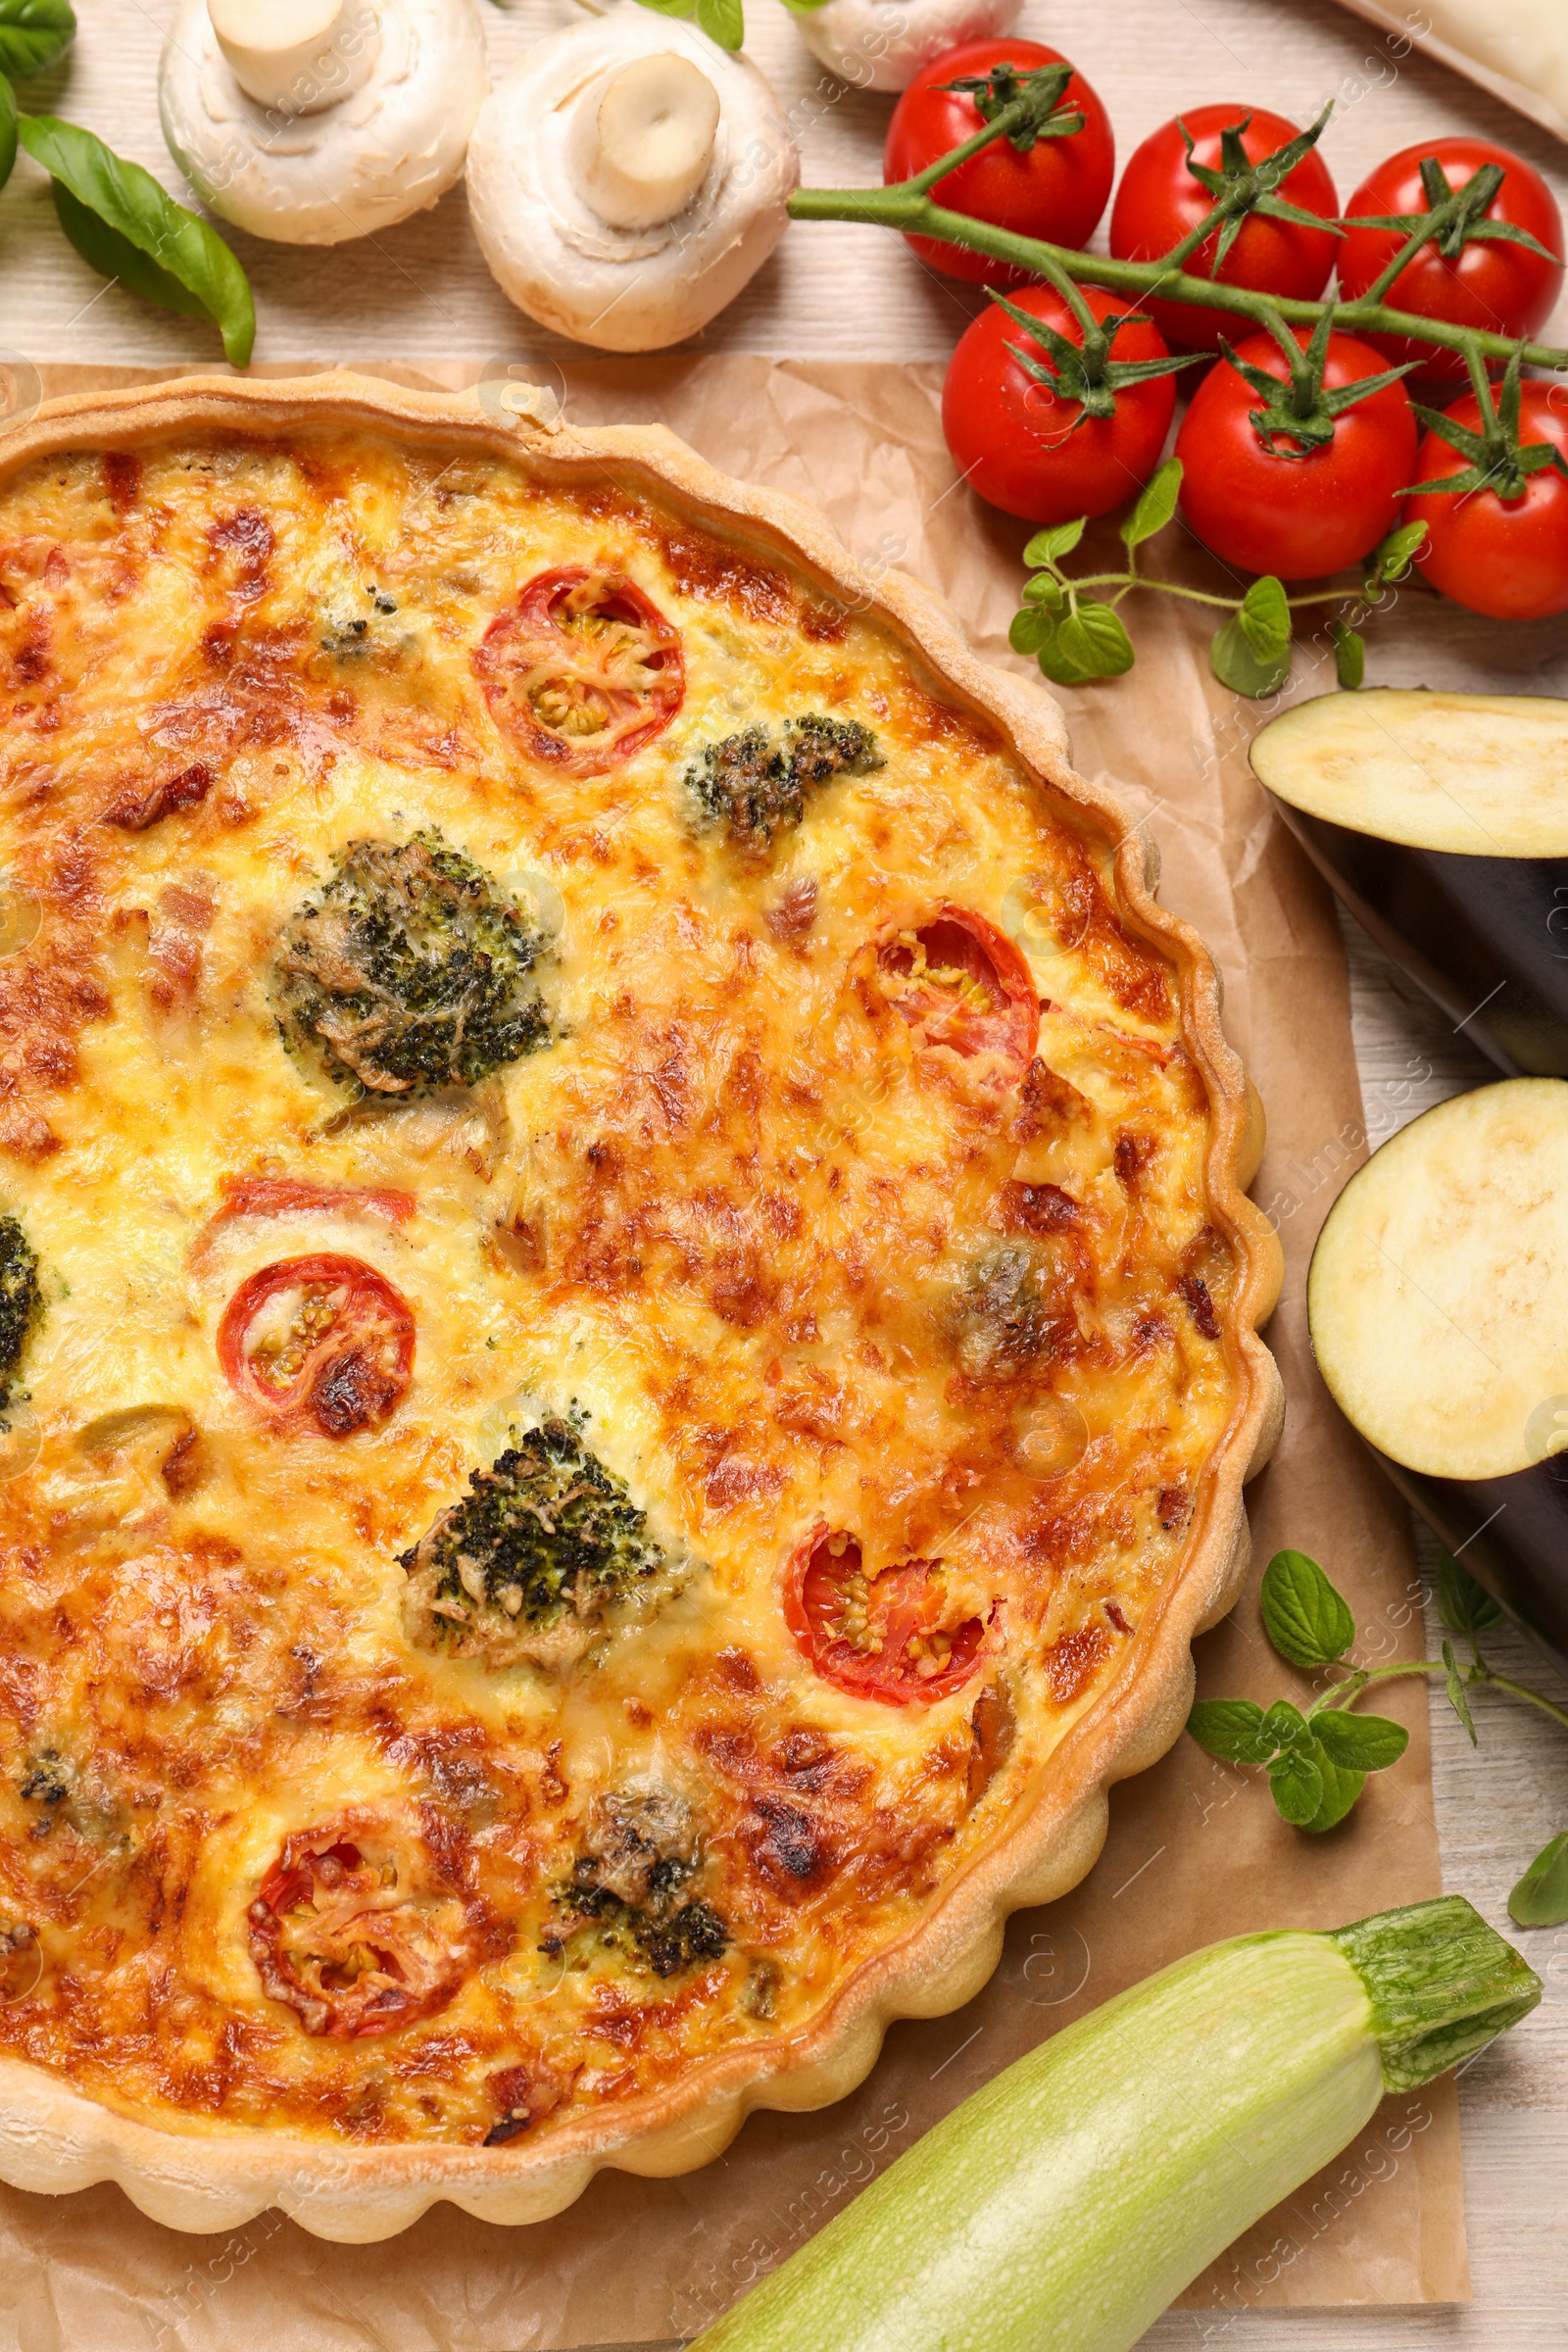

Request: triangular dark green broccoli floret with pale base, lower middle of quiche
left=400, top=1418, right=665, bottom=1668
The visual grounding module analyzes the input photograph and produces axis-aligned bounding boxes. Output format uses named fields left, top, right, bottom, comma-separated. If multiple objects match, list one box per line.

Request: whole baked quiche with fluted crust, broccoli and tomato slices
left=0, top=376, right=1279, bottom=2239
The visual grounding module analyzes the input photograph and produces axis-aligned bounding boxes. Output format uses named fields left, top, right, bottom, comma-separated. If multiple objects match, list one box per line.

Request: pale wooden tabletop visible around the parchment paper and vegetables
left=0, top=0, right=1568, bottom=2352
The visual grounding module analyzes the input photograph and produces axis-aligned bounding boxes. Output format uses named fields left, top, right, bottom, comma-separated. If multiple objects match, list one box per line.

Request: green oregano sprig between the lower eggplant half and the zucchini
left=1187, top=1552, right=1568, bottom=1927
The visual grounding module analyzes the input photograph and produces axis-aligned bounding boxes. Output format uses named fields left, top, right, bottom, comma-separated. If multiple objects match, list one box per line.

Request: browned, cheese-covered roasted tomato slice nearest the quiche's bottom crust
left=247, top=1828, right=475, bottom=2041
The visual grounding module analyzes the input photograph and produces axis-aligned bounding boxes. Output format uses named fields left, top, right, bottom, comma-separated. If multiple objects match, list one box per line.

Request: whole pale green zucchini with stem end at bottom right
left=691, top=1895, right=1540, bottom=2352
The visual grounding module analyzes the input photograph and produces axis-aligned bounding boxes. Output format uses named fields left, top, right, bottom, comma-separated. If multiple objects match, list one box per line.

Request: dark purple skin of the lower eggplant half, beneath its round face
left=1368, top=1446, right=1568, bottom=1672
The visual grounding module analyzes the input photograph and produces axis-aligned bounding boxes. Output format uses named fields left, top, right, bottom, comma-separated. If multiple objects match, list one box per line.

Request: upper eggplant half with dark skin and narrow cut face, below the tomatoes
left=1250, top=687, right=1568, bottom=1077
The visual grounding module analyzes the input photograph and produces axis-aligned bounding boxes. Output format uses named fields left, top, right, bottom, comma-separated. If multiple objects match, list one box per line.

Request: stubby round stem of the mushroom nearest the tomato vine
left=573, top=49, right=719, bottom=228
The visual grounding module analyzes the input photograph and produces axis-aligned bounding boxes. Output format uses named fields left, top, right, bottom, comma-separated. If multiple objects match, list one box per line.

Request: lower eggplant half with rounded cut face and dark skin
left=1307, top=1077, right=1568, bottom=1663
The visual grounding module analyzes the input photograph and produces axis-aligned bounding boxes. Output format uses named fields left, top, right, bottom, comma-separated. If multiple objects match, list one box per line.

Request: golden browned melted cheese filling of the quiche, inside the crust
left=0, top=433, right=1239, bottom=2140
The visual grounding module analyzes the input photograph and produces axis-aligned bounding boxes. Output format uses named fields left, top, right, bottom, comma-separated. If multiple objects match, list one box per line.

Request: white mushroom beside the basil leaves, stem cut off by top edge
left=158, top=0, right=489, bottom=245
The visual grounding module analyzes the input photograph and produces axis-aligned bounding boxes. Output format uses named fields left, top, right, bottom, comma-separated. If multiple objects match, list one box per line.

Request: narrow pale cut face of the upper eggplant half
left=1250, top=687, right=1568, bottom=858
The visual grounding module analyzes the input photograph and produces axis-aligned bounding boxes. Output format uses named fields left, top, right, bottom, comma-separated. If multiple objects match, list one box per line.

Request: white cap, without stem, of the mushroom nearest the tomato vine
left=467, top=0, right=800, bottom=351
